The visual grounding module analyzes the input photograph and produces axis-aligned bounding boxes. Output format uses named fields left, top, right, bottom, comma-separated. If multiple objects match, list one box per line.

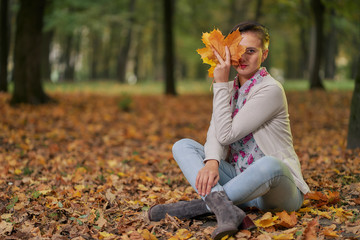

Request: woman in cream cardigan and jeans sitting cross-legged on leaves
left=149, top=22, right=309, bottom=239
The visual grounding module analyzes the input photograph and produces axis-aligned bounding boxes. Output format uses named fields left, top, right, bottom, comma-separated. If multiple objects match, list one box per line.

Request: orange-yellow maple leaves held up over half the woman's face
left=196, top=29, right=245, bottom=77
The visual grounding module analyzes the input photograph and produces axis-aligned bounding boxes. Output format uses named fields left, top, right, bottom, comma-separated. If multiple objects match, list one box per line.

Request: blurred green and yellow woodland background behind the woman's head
left=0, top=0, right=360, bottom=92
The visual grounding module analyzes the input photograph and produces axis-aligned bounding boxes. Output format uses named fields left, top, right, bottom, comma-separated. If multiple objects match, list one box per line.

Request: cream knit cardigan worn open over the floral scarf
left=204, top=75, right=309, bottom=194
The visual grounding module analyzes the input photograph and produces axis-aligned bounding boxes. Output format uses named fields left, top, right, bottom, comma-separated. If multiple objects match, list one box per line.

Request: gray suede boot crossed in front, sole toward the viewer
left=205, top=191, right=246, bottom=240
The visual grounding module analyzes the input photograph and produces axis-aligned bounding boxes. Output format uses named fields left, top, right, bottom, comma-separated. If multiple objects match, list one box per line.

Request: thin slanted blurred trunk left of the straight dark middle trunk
left=118, top=0, right=136, bottom=83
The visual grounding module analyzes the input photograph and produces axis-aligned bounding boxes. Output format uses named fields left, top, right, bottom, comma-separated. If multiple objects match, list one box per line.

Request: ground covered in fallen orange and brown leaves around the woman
left=0, top=92, right=360, bottom=239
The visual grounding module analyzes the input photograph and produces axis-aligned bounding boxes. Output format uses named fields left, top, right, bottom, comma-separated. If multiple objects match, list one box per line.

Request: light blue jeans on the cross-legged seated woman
left=173, top=139, right=304, bottom=211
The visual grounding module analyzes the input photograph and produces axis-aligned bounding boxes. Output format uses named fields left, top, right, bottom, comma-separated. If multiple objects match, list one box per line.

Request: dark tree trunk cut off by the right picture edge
left=347, top=57, right=360, bottom=149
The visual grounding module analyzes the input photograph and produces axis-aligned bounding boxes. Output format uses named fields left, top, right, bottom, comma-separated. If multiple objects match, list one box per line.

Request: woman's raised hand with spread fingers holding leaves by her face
left=213, top=46, right=231, bottom=83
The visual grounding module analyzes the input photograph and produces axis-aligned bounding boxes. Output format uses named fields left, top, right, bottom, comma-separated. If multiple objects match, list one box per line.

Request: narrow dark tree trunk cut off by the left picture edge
left=0, top=0, right=10, bottom=92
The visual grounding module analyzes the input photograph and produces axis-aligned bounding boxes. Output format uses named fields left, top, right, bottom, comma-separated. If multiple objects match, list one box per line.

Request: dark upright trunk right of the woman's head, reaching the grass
left=309, top=0, right=325, bottom=89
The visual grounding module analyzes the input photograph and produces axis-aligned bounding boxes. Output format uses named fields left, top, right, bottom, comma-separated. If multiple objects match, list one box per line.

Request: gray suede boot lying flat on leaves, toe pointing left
left=148, top=199, right=211, bottom=221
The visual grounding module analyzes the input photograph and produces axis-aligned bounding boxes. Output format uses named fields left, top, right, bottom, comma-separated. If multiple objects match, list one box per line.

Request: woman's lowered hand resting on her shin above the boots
left=195, top=159, right=220, bottom=196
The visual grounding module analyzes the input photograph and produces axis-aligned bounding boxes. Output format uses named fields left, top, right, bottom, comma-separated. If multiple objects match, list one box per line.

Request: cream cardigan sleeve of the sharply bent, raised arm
left=213, top=80, right=285, bottom=145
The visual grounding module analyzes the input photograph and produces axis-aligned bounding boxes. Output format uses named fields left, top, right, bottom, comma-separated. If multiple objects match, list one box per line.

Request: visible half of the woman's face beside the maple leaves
left=235, top=32, right=269, bottom=80
